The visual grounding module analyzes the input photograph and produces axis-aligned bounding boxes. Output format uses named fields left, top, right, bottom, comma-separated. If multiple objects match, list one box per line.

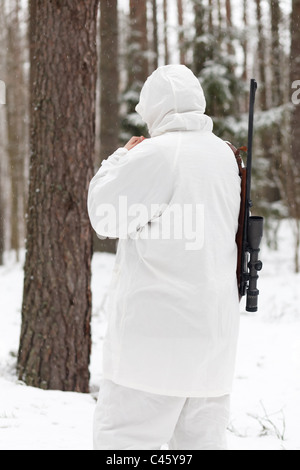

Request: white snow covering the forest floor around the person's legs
left=0, top=222, right=300, bottom=450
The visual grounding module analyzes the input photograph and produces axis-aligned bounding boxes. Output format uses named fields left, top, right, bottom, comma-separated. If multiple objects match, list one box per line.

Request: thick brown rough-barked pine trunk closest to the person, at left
left=18, top=0, right=98, bottom=392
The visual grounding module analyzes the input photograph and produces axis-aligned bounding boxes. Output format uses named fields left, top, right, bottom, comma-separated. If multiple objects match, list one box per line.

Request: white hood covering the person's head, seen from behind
left=136, top=65, right=213, bottom=137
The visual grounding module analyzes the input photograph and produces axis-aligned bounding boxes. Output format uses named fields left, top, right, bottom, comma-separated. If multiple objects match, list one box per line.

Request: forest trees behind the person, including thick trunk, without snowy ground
left=0, top=0, right=300, bottom=391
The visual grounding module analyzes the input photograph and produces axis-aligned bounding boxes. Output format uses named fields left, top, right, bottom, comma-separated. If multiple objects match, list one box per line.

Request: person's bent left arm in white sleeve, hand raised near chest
left=88, top=139, right=174, bottom=238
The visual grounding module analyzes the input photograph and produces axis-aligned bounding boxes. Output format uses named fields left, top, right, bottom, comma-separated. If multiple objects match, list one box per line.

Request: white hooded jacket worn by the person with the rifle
left=88, top=65, right=240, bottom=397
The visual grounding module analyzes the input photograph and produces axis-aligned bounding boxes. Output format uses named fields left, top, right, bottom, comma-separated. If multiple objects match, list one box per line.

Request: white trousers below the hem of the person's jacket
left=94, top=380, right=230, bottom=450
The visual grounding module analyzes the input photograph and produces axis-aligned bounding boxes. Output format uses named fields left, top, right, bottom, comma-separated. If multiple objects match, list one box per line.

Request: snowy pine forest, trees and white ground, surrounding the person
left=0, top=0, right=300, bottom=450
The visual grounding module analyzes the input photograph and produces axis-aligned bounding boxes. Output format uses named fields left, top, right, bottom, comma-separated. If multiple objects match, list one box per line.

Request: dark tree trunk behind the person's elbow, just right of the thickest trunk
left=93, top=0, right=120, bottom=253
